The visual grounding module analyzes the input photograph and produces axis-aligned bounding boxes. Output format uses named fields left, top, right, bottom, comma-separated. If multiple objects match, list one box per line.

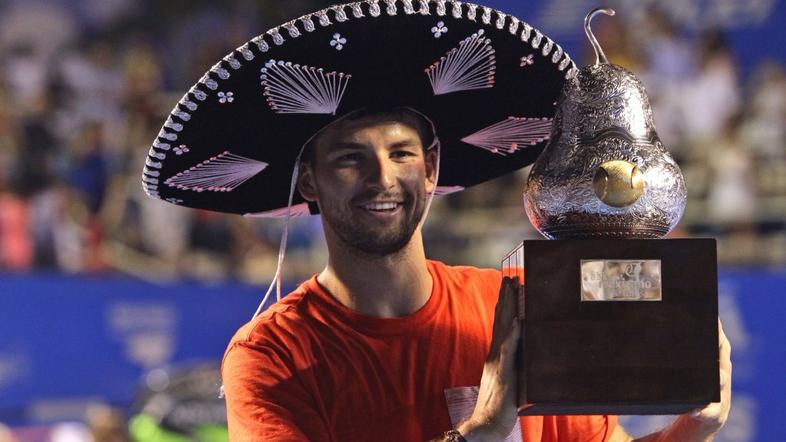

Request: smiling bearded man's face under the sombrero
left=301, top=119, right=436, bottom=256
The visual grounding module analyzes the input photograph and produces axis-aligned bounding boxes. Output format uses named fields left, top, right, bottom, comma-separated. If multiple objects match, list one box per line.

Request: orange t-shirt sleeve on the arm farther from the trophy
left=221, top=342, right=328, bottom=442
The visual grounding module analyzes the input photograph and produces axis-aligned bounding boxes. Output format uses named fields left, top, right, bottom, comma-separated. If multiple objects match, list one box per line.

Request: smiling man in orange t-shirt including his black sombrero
left=144, top=0, right=728, bottom=441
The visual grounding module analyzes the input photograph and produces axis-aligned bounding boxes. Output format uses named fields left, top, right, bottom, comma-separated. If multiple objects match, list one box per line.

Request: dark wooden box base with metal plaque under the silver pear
left=503, top=239, right=720, bottom=415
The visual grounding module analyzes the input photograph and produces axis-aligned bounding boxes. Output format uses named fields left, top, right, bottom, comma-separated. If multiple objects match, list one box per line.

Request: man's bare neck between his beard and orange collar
left=317, top=229, right=433, bottom=318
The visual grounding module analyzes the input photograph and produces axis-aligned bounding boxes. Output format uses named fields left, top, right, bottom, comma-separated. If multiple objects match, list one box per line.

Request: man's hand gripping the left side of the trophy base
left=458, top=277, right=522, bottom=442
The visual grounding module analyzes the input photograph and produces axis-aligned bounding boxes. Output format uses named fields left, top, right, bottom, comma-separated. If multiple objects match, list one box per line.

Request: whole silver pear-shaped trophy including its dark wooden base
left=502, top=8, right=720, bottom=415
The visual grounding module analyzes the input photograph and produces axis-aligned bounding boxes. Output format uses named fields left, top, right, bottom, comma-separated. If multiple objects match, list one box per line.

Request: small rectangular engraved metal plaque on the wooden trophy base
left=581, top=259, right=662, bottom=301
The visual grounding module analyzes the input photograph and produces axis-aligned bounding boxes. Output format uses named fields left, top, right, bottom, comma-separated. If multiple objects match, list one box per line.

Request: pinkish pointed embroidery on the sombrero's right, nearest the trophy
left=461, top=117, right=551, bottom=156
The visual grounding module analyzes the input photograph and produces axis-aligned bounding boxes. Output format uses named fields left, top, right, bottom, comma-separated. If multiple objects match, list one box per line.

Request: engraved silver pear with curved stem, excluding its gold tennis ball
left=524, top=8, right=687, bottom=239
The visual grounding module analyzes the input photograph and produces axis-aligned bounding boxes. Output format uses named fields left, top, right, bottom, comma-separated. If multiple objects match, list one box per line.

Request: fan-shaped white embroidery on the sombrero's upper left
left=260, top=60, right=352, bottom=115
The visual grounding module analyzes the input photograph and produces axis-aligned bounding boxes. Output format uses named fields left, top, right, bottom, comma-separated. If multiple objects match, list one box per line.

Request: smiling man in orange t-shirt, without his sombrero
left=223, top=110, right=728, bottom=441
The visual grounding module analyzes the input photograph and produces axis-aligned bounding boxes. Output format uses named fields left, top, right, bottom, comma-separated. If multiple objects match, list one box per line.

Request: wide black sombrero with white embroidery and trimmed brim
left=143, top=0, right=575, bottom=216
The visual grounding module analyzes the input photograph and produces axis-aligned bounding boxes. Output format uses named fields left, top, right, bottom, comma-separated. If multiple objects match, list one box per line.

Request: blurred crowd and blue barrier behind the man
left=0, top=0, right=786, bottom=442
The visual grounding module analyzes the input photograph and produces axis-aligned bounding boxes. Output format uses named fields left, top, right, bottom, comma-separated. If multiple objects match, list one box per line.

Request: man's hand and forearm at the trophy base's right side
left=609, top=320, right=731, bottom=442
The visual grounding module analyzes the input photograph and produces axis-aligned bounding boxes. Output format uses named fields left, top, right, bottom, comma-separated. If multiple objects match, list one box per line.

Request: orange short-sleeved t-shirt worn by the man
left=222, top=261, right=616, bottom=442
